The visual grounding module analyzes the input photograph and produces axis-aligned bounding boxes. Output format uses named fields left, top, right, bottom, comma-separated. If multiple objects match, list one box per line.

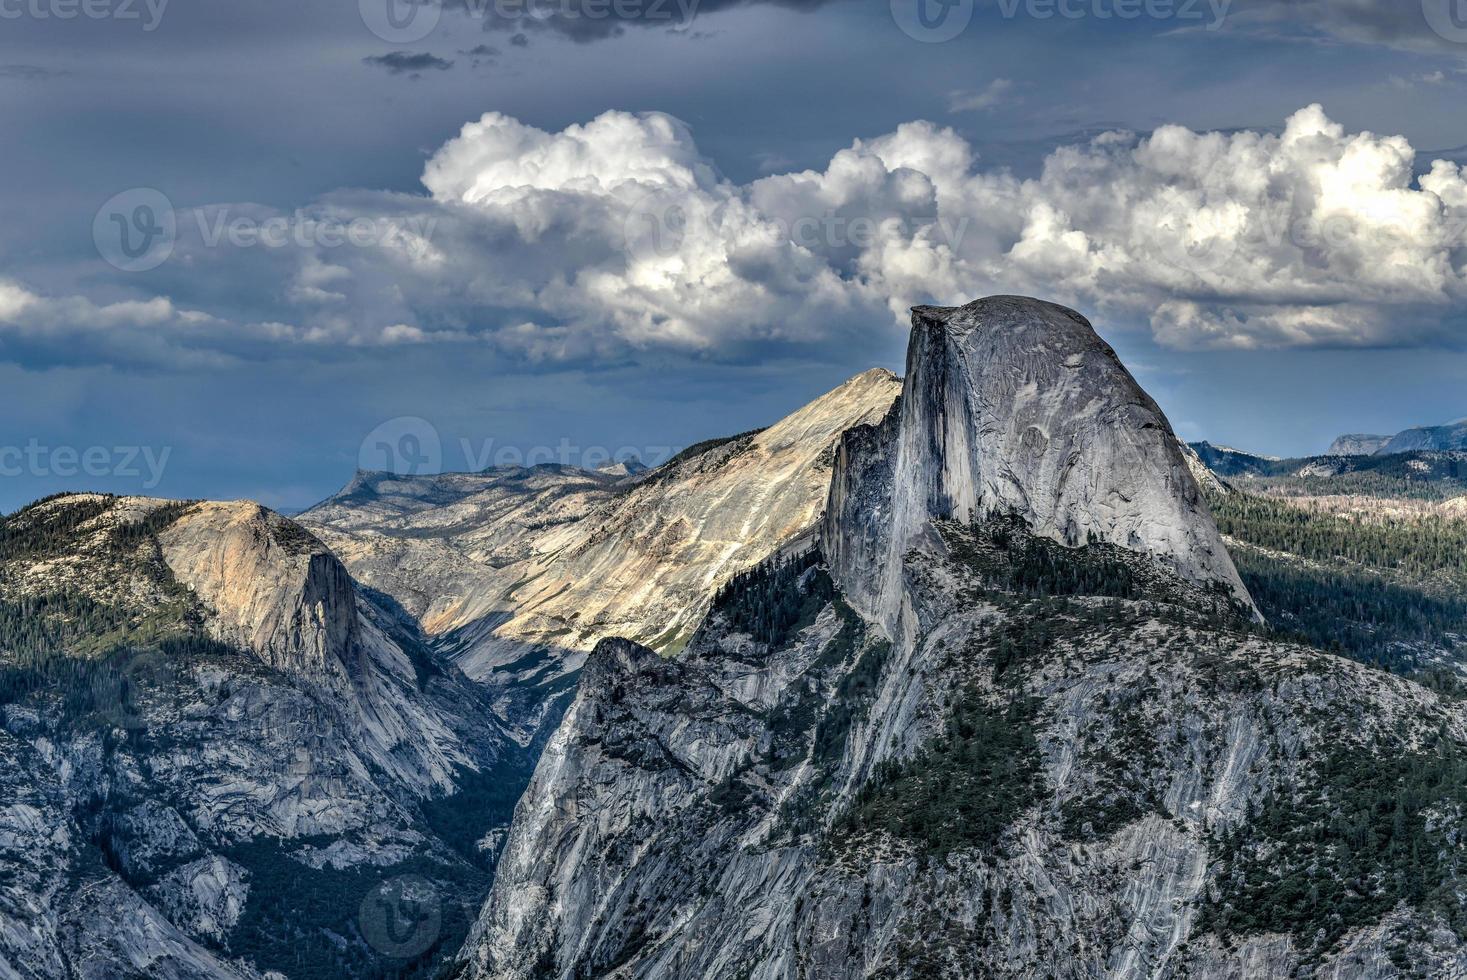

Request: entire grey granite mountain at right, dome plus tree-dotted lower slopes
left=461, top=298, right=1467, bottom=980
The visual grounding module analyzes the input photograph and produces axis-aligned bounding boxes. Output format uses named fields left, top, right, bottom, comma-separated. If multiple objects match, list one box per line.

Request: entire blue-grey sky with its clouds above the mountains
left=0, top=0, right=1467, bottom=509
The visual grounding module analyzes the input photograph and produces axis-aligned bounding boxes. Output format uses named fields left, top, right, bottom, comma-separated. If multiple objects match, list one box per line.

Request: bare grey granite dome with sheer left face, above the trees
left=823, top=296, right=1251, bottom=624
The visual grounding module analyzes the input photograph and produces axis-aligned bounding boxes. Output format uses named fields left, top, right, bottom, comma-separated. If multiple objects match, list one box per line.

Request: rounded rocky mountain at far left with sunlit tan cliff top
left=0, top=494, right=527, bottom=980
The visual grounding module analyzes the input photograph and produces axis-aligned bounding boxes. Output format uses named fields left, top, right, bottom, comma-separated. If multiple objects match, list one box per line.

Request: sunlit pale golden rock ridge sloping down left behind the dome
left=301, top=368, right=899, bottom=741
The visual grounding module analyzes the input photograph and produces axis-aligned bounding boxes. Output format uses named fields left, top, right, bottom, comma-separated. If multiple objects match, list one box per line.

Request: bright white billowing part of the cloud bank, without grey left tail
left=413, top=106, right=1467, bottom=348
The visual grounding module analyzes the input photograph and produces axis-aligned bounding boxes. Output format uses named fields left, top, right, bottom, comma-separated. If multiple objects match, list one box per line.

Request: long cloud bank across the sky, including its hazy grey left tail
left=17, top=106, right=1467, bottom=361
